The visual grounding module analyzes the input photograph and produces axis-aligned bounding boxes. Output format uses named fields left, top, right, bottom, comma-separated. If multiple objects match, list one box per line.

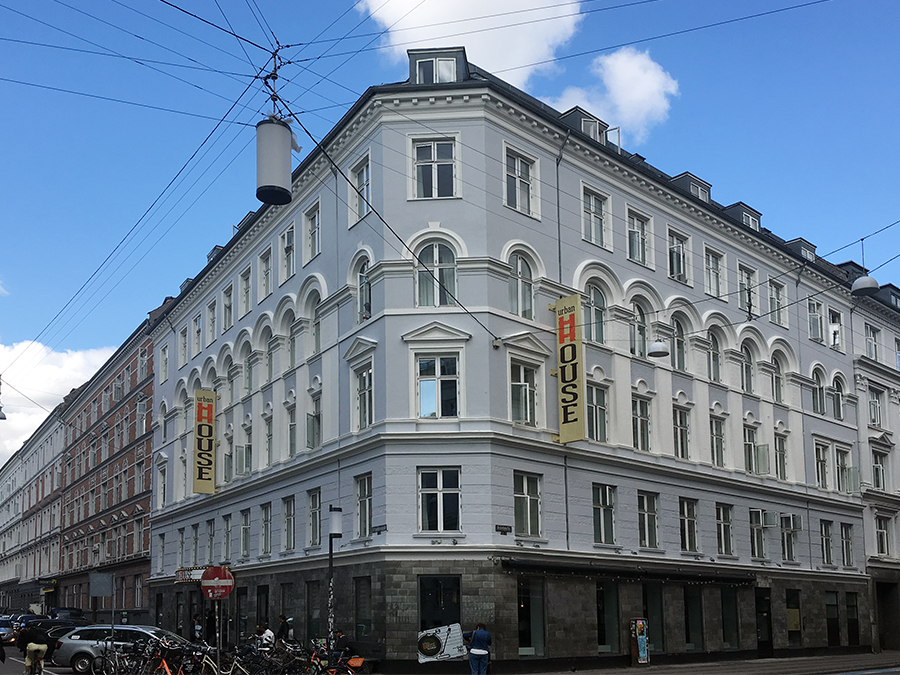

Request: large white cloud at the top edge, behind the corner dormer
left=359, top=0, right=581, bottom=88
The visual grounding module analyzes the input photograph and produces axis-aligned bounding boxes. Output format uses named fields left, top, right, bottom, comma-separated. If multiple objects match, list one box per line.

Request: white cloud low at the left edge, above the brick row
left=0, top=341, right=115, bottom=464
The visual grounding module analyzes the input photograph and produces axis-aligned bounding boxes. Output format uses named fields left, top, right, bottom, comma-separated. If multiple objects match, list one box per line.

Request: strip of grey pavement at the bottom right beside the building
left=536, top=651, right=900, bottom=675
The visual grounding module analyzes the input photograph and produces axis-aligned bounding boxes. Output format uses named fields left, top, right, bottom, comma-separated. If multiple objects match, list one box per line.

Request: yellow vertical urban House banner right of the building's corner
left=556, top=294, right=585, bottom=443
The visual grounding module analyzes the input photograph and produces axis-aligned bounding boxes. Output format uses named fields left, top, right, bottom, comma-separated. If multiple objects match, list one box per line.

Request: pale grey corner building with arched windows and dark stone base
left=149, top=48, right=900, bottom=672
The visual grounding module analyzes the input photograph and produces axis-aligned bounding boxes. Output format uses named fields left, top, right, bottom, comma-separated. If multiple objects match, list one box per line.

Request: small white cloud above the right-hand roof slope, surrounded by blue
left=547, top=47, right=678, bottom=144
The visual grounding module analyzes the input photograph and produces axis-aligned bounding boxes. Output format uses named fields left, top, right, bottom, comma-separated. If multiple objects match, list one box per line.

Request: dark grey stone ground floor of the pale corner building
left=150, top=549, right=875, bottom=673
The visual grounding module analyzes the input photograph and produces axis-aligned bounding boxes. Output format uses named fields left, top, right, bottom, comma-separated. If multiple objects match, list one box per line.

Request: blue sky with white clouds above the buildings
left=0, top=0, right=900, bottom=461
